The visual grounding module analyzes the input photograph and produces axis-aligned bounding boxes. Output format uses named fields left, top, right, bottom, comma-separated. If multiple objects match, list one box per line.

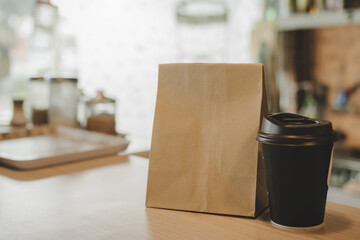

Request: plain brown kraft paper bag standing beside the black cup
left=146, top=63, right=268, bottom=217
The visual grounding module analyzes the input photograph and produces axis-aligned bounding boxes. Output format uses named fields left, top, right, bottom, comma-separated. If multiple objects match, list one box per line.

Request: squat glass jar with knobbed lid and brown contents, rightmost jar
left=86, top=91, right=116, bottom=135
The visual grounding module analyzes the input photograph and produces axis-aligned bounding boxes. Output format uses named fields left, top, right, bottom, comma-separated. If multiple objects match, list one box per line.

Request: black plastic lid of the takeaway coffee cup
left=257, top=113, right=337, bottom=146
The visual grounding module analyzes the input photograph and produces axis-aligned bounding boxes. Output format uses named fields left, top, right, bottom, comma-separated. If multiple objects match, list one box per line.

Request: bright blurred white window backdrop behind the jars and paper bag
left=0, top=0, right=262, bottom=138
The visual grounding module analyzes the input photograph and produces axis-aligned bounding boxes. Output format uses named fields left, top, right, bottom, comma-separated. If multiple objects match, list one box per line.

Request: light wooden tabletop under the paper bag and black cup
left=0, top=153, right=360, bottom=240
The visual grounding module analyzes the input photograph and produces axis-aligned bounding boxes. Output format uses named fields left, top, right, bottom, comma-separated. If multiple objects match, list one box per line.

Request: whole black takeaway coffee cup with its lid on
left=257, top=113, right=337, bottom=227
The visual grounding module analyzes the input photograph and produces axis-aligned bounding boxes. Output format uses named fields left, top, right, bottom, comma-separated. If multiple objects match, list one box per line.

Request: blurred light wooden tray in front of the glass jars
left=0, top=126, right=129, bottom=170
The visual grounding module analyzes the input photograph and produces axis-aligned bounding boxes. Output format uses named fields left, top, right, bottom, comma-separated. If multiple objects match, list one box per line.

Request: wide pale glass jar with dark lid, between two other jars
left=49, top=78, right=79, bottom=127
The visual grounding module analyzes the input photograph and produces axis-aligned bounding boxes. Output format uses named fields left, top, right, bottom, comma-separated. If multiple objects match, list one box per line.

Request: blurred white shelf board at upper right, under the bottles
left=275, top=10, right=360, bottom=32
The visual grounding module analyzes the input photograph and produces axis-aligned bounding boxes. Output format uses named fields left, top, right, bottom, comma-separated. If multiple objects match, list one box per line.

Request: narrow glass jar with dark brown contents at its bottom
left=29, top=77, right=50, bottom=125
